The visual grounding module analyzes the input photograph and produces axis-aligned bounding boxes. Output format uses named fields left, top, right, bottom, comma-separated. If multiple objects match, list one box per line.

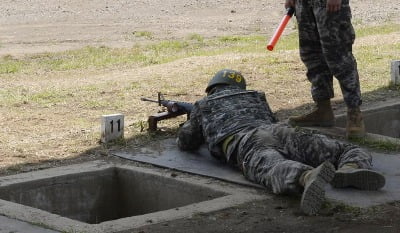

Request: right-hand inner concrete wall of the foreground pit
left=117, top=169, right=226, bottom=216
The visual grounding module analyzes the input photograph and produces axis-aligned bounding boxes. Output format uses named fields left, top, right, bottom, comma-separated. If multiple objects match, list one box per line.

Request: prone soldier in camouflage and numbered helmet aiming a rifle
left=177, top=69, right=385, bottom=214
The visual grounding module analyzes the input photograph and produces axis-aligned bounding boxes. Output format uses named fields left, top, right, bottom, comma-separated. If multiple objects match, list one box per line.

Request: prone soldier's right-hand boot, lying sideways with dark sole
left=332, top=163, right=385, bottom=190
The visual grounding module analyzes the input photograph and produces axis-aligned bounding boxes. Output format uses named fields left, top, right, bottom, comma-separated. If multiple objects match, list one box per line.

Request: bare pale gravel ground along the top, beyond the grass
left=0, top=0, right=400, bottom=55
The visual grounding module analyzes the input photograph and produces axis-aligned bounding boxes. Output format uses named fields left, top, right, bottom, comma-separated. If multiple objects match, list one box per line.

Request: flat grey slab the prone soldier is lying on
left=112, top=139, right=400, bottom=207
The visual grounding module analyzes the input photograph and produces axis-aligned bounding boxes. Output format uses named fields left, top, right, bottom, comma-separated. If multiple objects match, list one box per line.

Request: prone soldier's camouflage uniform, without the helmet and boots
left=177, top=86, right=371, bottom=193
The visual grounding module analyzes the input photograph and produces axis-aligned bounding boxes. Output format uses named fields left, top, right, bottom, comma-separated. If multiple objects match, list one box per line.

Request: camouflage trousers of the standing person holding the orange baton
left=296, top=0, right=362, bottom=107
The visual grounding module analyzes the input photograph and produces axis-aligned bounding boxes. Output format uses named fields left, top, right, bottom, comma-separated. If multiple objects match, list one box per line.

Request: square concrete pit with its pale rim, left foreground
left=0, top=162, right=262, bottom=232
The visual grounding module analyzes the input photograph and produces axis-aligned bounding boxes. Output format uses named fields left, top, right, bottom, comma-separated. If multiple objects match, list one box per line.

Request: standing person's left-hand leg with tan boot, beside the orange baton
left=289, top=0, right=334, bottom=126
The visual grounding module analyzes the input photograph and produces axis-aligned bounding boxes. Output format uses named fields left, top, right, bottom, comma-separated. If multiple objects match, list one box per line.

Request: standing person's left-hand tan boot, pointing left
left=289, top=100, right=335, bottom=127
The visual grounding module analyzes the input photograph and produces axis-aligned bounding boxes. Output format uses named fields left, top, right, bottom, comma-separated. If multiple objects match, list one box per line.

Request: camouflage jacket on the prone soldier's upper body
left=177, top=86, right=276, bottom=159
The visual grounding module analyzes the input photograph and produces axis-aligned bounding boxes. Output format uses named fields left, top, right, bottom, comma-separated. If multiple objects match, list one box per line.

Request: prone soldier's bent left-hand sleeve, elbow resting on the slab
left=176, top=103, right=204, bottom=150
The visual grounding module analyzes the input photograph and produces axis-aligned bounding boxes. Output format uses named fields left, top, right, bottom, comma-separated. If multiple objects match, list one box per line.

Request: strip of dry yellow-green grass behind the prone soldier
left=0, top=24, right=400, bottom=173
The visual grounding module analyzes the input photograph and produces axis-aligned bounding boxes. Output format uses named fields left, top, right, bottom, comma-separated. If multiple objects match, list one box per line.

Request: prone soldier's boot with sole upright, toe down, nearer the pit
left=299, top=161, right=335, bottom=215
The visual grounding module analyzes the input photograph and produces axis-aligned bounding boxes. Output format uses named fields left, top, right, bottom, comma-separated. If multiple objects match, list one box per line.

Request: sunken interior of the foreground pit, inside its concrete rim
left=0, top=167, right=227, bottom=224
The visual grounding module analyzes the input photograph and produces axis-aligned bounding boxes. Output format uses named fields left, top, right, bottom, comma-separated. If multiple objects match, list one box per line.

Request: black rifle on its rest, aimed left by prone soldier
left=140, top=92, right=193, bottom=131
